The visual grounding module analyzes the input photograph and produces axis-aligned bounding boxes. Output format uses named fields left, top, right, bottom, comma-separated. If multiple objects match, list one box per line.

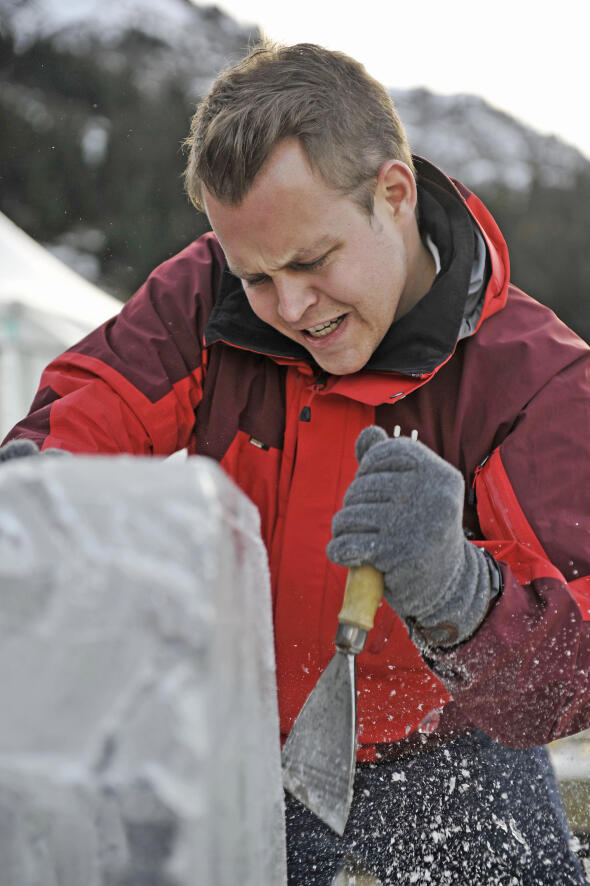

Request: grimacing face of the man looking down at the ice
left=204, top=139, right=415, bottom=375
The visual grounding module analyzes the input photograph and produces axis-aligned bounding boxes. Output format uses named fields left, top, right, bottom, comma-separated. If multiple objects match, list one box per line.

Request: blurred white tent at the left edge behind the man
left=0, top=213, right=121, bottom=439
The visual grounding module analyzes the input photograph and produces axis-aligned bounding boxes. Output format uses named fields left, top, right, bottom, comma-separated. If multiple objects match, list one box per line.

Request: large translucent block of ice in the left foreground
left=0, top=457, right=286, bottom=886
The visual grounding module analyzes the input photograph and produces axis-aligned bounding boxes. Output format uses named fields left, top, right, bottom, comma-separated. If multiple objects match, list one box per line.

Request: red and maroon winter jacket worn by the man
left=9, top=160, right=590, bottom=758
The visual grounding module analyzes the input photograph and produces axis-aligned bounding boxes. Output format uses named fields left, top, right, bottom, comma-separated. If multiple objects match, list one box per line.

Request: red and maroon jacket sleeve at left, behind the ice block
left=6, top=234, right=223, bottom=455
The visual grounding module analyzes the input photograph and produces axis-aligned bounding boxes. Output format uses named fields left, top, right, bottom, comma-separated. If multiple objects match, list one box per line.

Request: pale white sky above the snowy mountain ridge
left=214, top=0, right=590, bottom=158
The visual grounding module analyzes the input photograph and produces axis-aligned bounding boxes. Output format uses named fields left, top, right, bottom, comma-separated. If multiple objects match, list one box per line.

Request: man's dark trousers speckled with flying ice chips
left=286, top=732, right=586, bottom=886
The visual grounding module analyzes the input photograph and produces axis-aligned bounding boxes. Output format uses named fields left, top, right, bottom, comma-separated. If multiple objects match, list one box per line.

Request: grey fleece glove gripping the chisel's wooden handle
left=327, top=427, right=499, bottom=649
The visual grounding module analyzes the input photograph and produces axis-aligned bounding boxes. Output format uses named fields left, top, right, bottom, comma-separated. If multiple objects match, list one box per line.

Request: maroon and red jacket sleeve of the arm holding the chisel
left=427, top=349, right=590, bottom=747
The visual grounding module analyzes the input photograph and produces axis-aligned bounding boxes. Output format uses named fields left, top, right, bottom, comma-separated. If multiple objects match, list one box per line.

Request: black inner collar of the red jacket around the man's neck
left=205, top=157, right=500, bottom=377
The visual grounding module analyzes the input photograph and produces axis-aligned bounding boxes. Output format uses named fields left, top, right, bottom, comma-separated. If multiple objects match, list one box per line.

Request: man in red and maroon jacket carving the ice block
left=5, top=44, right=590, bottom=886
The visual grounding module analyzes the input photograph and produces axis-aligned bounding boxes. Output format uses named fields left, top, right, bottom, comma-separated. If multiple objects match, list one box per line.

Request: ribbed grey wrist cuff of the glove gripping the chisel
left=405, top=541, right=502, bottom=652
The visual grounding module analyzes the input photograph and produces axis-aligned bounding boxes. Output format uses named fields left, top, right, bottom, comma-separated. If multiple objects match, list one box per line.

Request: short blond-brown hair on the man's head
left=185, top=41, right=414, bottom=215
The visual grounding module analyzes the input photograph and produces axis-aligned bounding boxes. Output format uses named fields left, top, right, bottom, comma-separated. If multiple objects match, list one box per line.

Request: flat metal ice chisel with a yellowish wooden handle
left=282, top=566, right=383, bottom=836
